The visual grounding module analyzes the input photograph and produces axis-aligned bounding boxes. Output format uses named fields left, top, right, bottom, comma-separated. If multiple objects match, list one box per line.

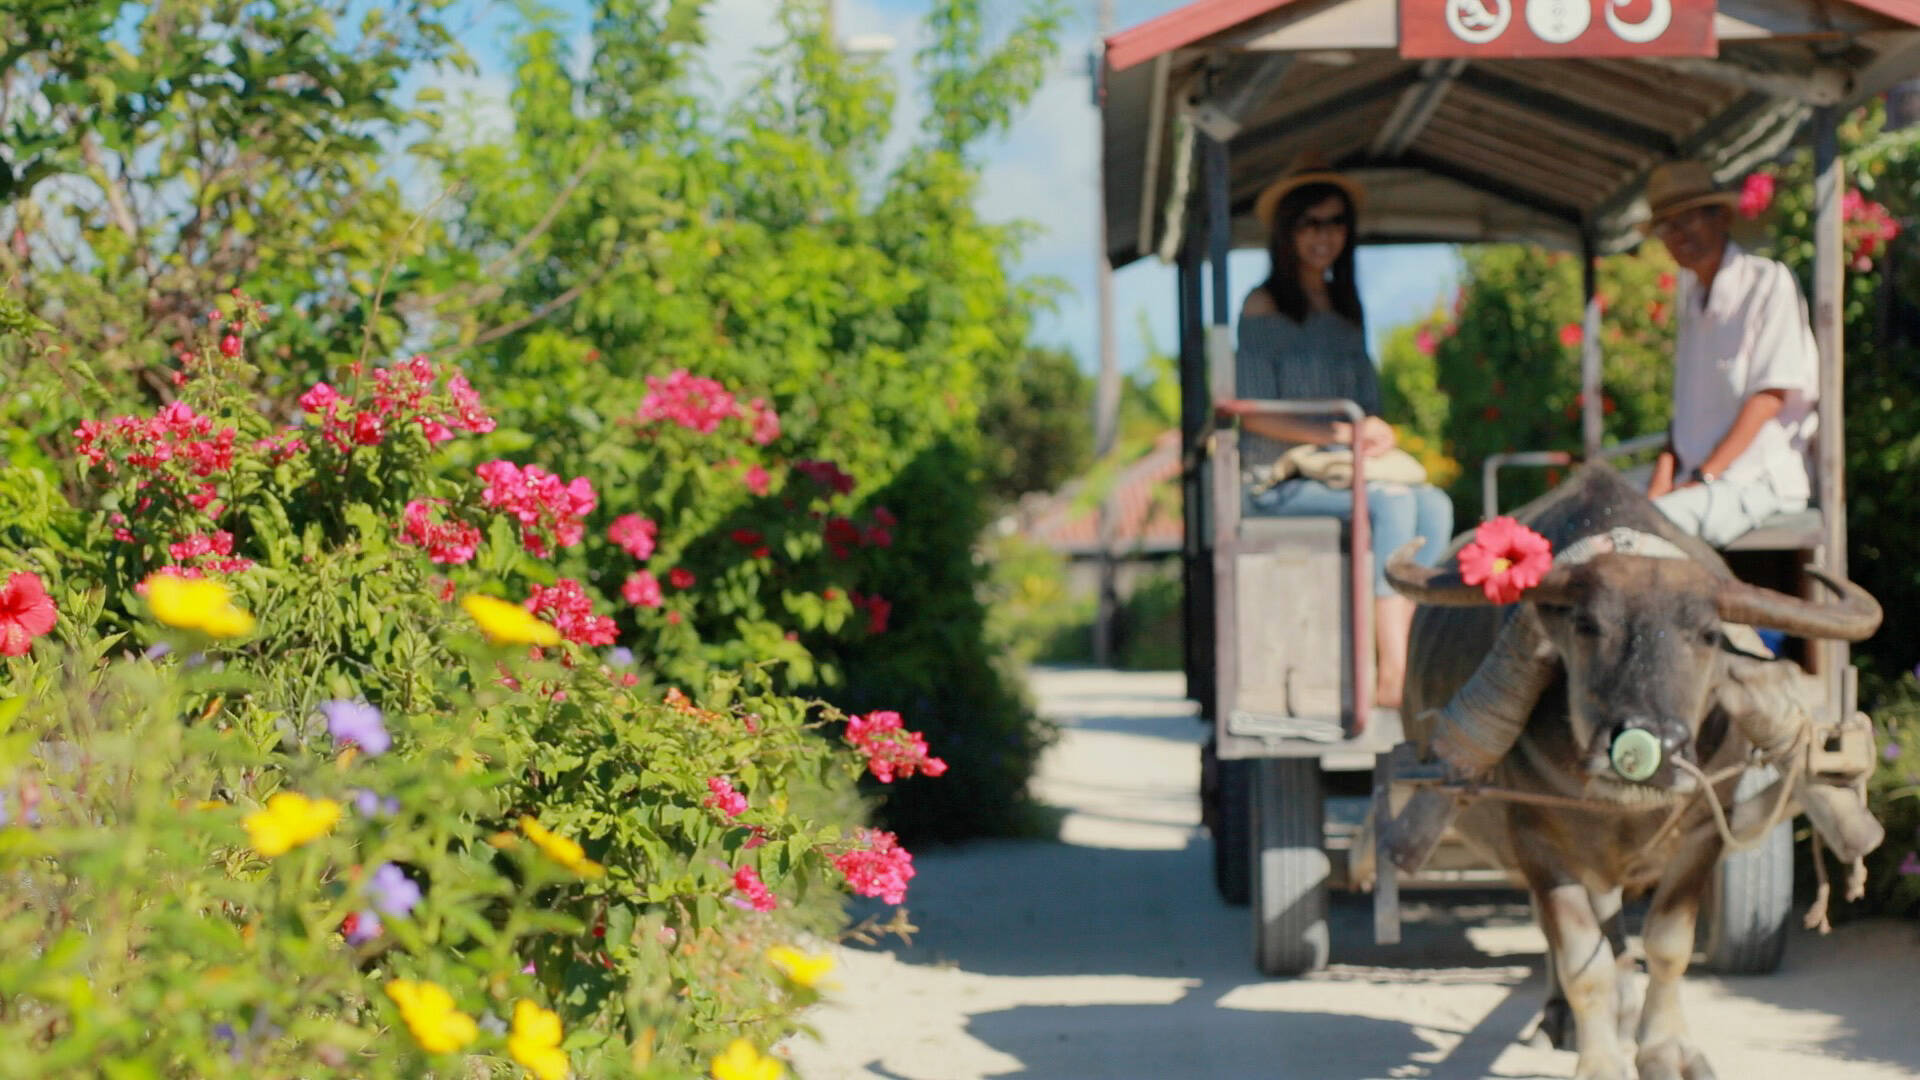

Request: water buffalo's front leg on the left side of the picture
left=1526, top=871, right=1634, bottom=1080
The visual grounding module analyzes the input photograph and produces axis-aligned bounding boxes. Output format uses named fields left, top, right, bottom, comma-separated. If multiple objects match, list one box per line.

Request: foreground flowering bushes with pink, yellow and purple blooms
left=0, top=322, right=945, bottom=1080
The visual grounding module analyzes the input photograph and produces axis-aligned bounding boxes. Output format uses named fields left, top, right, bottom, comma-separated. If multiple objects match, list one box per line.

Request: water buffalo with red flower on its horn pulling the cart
left=1388, top=465, right=1880, bottom=1080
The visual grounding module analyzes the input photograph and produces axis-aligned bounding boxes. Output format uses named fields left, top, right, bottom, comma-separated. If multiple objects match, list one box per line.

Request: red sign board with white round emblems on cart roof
left=1400, top=0, right=1718, bottom=60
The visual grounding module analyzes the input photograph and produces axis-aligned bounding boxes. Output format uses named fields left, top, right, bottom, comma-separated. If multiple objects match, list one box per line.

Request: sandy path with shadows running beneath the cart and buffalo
left=785, top=671, right=1920, bottom=1080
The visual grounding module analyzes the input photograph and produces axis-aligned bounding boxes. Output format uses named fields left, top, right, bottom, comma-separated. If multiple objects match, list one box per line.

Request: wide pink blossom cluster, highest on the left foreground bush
left=300, top=356, right=493, bottom=452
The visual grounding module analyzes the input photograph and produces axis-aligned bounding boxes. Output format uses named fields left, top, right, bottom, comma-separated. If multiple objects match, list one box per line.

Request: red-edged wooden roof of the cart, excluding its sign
left=1102, top=0, right=1920, bottom=267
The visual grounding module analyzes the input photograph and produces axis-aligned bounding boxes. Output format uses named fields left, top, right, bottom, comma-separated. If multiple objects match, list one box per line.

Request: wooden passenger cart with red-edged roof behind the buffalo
left=1102, top=0, right=1920, bottom=974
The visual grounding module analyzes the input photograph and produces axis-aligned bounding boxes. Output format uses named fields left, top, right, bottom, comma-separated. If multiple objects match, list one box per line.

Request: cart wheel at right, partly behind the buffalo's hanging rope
left=1701, top=767, right=1793, bottom=974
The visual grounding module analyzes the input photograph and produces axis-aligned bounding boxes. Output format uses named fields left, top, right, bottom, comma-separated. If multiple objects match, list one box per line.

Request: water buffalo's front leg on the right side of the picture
left=1638, top=834, right=1720, bottom=1080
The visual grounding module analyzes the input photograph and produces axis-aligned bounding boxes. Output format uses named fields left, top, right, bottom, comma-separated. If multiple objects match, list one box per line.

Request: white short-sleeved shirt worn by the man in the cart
left=1672, top=244, right=1820, bottom=500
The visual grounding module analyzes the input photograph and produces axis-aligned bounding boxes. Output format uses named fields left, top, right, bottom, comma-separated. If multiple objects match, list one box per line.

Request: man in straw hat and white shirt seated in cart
left=1645, top=161, right=1820, bottom=546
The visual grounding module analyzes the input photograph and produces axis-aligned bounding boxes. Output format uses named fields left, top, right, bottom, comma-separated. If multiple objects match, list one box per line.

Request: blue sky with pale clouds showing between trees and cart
left=422, top=0, right=1455, bottom=371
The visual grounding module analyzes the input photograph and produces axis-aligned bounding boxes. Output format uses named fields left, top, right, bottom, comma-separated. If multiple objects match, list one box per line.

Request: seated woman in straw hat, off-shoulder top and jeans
left=1235, top=160, right=1453, bottom=707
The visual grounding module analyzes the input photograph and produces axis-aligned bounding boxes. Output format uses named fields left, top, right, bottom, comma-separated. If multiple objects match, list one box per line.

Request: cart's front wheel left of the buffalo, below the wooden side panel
left=1250, top=757, right=1331, bottom=976
